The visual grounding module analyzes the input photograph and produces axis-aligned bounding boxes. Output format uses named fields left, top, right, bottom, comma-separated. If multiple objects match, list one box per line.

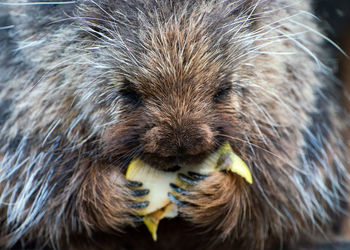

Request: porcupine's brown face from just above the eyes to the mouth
left=110, top=56, right=239, bottom=170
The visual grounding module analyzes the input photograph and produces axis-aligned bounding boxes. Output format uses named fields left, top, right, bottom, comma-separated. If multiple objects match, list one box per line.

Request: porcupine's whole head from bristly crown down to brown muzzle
left=92, top=2, right=262, bottom=171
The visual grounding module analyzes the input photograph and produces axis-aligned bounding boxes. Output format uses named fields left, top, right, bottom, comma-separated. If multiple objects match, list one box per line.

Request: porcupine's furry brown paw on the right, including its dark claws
left=169, top=171, right=248, bottom=234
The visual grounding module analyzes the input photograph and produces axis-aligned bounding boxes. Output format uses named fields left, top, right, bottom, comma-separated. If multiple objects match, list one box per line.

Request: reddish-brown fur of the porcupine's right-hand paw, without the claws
left=180, top=172, right=249, bottom=238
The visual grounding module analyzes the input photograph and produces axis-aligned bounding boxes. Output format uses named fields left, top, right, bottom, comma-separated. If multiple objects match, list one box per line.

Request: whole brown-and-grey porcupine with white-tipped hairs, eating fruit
left=0, top=0, right=348, bottom=249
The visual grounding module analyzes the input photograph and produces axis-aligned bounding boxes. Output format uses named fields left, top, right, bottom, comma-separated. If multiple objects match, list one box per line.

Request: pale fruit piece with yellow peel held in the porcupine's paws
left=126, top=143, right=253, bottom=241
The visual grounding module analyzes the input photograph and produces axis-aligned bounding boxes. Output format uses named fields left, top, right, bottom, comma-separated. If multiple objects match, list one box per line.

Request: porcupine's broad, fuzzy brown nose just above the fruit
left=145, top=124, right=213, bottom=157
